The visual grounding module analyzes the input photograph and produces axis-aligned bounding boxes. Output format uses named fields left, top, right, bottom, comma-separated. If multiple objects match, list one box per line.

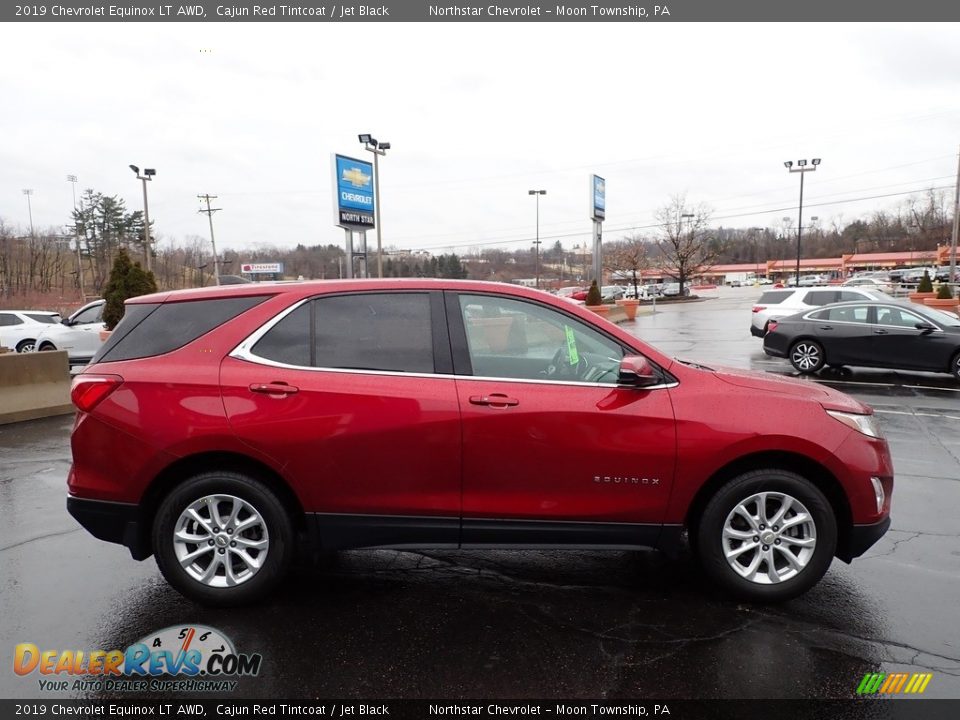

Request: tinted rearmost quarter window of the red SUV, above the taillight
left=91, top=295, right=267, bottom=363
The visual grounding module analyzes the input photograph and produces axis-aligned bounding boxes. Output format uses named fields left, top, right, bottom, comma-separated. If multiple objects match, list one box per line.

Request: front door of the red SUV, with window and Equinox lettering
left=447, top=293, right=676, bottom=545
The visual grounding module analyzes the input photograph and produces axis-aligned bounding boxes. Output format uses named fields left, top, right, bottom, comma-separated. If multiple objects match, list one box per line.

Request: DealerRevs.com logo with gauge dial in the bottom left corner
left=13, top=625, right=263, bottom=692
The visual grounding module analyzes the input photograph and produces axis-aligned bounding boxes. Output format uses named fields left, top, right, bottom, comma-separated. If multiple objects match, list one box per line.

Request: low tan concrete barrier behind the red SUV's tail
left=0, top=350, right=75, bottom=425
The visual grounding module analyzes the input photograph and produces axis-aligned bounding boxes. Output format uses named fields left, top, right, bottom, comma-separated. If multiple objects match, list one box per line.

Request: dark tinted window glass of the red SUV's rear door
left=250, top=293, right=435, bottom=373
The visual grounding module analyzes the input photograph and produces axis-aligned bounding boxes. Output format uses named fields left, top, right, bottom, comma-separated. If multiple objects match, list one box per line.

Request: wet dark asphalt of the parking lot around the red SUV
left=0, top=288, right=960, bottom=699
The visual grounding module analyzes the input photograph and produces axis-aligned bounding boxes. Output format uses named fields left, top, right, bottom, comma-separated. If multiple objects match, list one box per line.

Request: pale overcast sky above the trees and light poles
left=0, top=23, right=960, bottom=253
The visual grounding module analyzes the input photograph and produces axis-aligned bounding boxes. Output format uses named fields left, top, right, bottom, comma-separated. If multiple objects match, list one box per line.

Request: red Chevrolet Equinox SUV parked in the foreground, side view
left=67, top=280, right=893, bottom=605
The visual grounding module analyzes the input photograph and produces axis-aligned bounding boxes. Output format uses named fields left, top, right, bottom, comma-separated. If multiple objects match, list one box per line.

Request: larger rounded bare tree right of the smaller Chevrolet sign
left=654, top=195, right=720, bottom=296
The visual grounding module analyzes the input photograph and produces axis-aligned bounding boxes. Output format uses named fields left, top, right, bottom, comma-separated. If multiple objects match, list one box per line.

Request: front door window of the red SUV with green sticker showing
left=460, top=295, right=624, bottom=384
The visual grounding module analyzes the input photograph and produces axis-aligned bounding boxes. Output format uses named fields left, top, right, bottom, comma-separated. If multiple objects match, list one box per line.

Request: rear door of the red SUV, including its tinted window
left=221, top=291, right=461, bottom=548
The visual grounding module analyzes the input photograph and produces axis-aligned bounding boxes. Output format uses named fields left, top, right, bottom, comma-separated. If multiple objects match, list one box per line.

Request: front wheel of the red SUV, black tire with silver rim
left=697, top=468, right=837, bottom=602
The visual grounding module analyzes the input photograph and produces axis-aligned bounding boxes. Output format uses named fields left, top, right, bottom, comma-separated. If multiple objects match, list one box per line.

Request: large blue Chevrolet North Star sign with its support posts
left=331, top=154, right=376, bottom=278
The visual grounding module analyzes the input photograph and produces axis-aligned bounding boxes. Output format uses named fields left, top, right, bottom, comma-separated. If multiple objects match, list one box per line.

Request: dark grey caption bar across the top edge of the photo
left=0, top=0, right=960, bottom=23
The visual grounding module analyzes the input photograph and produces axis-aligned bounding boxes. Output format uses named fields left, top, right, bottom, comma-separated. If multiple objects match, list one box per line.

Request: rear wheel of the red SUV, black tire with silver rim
left=152, top=471, right=294, bottom=607
